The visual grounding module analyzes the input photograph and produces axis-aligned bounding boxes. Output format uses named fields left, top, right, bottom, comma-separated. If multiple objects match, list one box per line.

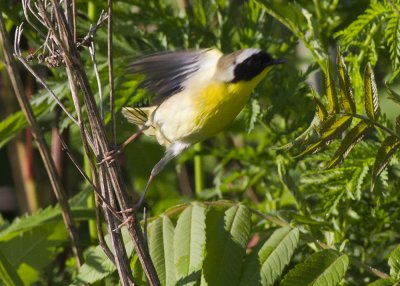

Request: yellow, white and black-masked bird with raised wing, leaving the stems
left=122, top=49, right=285, bottom=206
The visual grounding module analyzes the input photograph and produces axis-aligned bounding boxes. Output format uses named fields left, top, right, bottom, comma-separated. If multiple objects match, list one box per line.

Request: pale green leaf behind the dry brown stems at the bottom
left=71, top=228, right=134, bottom=286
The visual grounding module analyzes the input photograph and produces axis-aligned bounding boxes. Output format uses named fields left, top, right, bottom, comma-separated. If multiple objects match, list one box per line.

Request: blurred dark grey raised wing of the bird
left=127, top=50, right=207, bottom=104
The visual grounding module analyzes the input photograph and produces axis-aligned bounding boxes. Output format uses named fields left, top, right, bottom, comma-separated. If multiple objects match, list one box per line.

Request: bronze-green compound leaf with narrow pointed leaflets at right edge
left=299, top=51, right=400, bottom=189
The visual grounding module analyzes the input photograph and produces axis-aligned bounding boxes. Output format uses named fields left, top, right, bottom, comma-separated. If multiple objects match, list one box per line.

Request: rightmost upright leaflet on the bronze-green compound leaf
left=364, top=64, right=380, bottom=120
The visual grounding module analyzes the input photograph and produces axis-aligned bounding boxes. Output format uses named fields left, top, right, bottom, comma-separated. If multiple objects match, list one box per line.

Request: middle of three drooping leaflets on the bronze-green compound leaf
left=326, top=121, right=371, bottom=169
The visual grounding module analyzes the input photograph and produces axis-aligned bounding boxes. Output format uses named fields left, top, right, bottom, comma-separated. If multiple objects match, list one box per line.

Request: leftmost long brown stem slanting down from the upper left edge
left=0, top=15, right=84, bottom=268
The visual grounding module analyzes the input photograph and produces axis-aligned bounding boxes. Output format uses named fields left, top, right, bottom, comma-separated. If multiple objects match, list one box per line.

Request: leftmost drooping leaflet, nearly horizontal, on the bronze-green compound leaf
left=296, top=115, right=352, bottom=157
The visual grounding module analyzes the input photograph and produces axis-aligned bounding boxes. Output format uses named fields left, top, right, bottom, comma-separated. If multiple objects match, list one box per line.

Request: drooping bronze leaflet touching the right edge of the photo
left=371, top=135, right=400, bottom=190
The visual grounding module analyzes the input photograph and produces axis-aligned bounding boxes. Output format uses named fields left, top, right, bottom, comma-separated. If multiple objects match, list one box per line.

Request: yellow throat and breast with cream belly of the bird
left=152, top=70, right=267, bottom=146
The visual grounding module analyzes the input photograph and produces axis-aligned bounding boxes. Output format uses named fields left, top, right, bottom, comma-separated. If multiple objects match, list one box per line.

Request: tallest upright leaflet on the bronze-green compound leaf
left=337, top=50, right=356, bottom=114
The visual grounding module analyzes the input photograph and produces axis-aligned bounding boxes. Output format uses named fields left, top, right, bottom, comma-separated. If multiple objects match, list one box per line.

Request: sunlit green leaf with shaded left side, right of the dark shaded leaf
left=239, top=227, right=299, bottom=286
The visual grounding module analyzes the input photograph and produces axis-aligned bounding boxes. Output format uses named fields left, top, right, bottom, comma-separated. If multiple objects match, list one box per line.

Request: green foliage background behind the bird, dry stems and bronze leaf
left=0, top=0, right=400, bottom=285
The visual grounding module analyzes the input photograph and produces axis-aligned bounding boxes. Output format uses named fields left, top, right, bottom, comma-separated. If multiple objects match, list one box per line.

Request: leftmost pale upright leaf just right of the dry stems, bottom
left=149, top=215, right=176, bottom=285
